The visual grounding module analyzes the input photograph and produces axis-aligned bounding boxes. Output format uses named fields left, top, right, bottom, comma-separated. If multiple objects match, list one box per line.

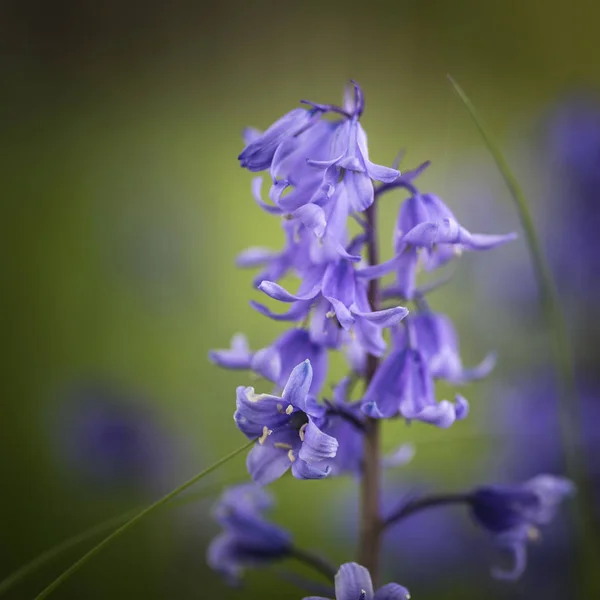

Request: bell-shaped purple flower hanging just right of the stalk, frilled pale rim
left=362, top=347, right=469, bottom=428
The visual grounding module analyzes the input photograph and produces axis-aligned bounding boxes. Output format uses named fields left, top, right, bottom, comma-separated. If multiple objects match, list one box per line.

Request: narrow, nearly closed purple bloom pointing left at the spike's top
left=238, top=108, right=316, bottom=172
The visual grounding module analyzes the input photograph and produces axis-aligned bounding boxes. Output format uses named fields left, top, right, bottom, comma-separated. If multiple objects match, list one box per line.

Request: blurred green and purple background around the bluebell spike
left=0, top=0, right=600, bottom=600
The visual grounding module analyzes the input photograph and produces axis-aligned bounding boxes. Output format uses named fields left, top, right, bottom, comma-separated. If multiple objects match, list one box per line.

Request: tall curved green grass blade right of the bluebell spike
left=448, top=75, right=600, bottom=595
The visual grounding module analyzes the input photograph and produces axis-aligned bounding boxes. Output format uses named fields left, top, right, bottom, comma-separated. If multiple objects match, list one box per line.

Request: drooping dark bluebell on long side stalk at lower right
left=469, top=475, right=575, bottom=579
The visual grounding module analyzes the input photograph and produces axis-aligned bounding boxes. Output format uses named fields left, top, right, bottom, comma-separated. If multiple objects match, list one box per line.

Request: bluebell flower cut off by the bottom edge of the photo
left=304, top=563, right=410, bottom=600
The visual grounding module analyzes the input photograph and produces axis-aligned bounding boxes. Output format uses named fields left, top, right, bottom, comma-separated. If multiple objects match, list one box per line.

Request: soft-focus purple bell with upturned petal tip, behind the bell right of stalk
left=409, top=312, right=496, bottom=384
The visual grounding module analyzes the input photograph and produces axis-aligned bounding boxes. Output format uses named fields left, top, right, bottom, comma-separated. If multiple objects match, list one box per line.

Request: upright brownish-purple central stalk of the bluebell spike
left=358, top=200, right=381, bottom=586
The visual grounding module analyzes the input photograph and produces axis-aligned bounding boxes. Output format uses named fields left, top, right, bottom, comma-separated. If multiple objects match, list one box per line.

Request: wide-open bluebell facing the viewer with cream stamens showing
left=234, top=360, right=338, bottom=485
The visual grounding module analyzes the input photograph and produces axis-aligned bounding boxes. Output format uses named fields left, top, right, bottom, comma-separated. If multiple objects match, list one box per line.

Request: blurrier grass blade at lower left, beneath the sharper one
left=0, top=479, right=245, bottom=596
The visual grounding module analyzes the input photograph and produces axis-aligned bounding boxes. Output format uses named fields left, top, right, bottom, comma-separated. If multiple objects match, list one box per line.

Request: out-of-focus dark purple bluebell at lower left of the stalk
left=207, top=483, right=292, bottom=584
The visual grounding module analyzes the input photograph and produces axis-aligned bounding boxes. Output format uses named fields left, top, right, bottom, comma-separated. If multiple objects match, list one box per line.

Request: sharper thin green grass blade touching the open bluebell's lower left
left=35, top=440, right=256, bottom=600
